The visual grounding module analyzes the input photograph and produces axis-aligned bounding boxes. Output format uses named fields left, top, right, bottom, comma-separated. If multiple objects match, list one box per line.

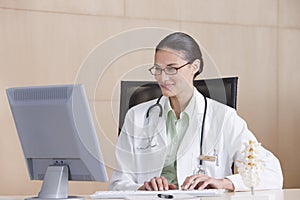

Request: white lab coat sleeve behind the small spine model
left=224, top=112, right=283, bottom=191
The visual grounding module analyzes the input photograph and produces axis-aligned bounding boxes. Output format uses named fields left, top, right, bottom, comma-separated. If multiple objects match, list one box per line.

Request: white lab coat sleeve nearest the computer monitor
left=108, top=110, right=141, bottom=190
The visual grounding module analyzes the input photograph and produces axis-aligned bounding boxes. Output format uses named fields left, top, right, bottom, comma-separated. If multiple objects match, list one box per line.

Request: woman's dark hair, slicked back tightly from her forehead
left=155, top=32, right=204, bottom=78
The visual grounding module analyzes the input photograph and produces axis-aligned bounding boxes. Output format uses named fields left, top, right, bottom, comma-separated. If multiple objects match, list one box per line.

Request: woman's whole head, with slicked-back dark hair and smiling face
left=152, top=33, right=203, bottom=103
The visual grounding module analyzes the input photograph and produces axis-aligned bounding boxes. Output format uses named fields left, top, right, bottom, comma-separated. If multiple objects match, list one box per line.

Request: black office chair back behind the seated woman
left=119, top=77, right=238, bottom=133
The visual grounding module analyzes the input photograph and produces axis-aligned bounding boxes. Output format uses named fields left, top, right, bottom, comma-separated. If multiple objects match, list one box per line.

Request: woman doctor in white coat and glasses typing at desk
left=109, top=32, right=283, bottom=191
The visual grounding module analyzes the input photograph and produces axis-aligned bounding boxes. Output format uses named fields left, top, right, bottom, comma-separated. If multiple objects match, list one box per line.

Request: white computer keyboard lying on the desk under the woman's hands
left=90, top=189, right=226, bottom=199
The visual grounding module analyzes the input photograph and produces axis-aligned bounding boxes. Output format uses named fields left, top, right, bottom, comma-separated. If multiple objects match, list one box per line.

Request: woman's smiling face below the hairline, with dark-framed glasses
left=154, top=49, right=198, bottom=97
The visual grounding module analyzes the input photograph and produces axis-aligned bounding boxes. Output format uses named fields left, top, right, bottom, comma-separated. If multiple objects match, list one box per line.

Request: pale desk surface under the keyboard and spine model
left=0, top=189, right=300, bottom=200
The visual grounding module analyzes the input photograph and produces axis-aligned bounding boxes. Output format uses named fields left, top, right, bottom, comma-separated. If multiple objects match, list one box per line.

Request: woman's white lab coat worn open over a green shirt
left=109, top=89, right=283, bottom=191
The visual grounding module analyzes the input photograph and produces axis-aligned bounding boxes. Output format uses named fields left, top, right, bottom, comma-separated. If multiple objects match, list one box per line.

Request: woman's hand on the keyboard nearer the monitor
left=139, top=176, right=176, bottom=191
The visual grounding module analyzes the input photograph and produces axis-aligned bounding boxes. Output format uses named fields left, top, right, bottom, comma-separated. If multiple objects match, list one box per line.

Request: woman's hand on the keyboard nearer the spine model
left=181, top=174, right=234, bottom=191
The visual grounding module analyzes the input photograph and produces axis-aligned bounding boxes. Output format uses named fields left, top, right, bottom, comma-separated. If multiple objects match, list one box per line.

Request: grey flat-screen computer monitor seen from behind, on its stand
left=6, top=84, right=108, bottom=199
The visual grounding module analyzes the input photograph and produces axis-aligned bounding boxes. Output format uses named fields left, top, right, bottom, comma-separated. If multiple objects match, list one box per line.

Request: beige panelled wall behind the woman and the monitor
left=0, top=0, right=300, bottom=195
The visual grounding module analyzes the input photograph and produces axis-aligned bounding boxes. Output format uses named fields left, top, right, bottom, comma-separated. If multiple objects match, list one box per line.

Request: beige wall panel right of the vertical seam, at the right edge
left=278, top=30, right=300, bottom=187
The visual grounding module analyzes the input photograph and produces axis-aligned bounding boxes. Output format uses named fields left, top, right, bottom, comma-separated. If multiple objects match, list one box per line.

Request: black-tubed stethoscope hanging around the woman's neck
left=139, top=95, right=207, bottom=174
